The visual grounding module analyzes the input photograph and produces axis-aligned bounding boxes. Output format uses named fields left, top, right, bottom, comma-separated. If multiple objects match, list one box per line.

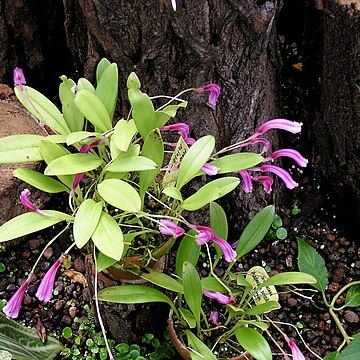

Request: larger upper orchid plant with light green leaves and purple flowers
left=0, top=59, right=307, bottom=358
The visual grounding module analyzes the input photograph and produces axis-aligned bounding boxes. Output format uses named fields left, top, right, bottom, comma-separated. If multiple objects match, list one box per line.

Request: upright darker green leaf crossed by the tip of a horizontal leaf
left=139, top=129, right=164, bottom=199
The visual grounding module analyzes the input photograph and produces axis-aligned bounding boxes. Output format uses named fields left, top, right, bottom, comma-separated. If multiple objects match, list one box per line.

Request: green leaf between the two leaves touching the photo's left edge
left=13, top=168, right=70, bottom=194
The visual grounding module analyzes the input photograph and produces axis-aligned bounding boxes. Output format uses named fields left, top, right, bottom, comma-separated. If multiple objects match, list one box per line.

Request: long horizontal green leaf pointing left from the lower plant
left=98, top=285, right=174, bottom=308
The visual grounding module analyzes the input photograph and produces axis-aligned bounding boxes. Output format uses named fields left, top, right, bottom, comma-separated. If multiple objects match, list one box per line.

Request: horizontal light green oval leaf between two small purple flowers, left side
left=44, top=153, right=102, bottom=175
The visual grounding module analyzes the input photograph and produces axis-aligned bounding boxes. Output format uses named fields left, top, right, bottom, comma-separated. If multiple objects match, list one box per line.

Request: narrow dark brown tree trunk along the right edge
left=313, top=0, right=360, bottom=226
